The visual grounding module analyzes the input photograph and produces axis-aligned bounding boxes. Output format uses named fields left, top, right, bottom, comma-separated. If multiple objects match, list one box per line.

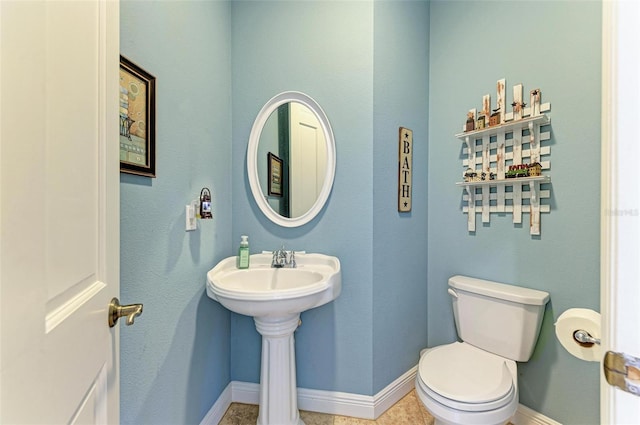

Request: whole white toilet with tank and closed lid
left=416, top=276, right=549, bottom=425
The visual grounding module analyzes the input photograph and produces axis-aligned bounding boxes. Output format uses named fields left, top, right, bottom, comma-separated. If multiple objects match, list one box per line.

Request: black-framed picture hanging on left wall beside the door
left=120, top=55, right=156, bottom=177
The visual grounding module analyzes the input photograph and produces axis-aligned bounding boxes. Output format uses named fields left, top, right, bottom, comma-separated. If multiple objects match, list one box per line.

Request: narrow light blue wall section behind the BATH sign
left=373, top=2, right=429, bottom=394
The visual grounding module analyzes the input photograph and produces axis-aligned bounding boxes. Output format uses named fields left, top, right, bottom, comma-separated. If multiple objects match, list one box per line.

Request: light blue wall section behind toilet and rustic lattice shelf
left=428, top=1, right=601, bottom=424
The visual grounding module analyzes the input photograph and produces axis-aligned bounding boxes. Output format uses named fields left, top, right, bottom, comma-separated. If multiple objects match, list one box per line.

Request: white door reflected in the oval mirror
left=289, top=102, right=327, bottom=217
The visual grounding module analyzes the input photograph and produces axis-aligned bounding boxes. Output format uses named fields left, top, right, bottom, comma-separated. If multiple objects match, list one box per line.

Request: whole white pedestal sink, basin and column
left=207, top=254, right=342, bottom=425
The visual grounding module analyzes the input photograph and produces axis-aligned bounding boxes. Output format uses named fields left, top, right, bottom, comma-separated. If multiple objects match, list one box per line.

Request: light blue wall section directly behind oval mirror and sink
left=231, top=1, right=373, bottom=394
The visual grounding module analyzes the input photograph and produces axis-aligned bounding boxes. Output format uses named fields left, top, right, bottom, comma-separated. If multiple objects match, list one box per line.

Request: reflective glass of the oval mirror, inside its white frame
left=258, top=102, right=327, bottom=218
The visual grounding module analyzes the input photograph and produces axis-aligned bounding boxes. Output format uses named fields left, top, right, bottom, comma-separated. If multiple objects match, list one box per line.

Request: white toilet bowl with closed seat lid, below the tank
left=416, top=342, right=518, bottom=425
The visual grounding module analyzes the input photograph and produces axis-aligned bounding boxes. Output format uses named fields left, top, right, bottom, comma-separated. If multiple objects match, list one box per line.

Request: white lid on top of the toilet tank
left=449, top=275, right=549, bottom=305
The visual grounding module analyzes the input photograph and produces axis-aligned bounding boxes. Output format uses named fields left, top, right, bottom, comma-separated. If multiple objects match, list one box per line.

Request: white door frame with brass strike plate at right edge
left=601, top=0, right=640, bottom=424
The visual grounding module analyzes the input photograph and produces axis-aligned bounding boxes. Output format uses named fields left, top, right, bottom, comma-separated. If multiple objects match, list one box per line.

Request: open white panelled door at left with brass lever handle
left=0, top=0, right=119, bottom=424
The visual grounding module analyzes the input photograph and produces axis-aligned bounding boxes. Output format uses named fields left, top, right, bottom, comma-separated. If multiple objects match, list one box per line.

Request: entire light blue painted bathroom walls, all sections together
left=121, top=0, right=601, bottom=424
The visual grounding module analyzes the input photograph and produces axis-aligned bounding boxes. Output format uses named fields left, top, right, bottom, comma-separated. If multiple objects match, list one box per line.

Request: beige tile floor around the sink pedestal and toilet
left=219, top=390, right=434, bottom=425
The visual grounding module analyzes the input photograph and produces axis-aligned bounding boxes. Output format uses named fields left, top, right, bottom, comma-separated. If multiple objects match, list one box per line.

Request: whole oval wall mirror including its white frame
left=247, top=91, right=336, bottom=227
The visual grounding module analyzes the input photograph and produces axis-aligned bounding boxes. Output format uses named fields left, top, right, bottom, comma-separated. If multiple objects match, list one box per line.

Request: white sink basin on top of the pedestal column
left=207, top=253, right=342, bottom=317
